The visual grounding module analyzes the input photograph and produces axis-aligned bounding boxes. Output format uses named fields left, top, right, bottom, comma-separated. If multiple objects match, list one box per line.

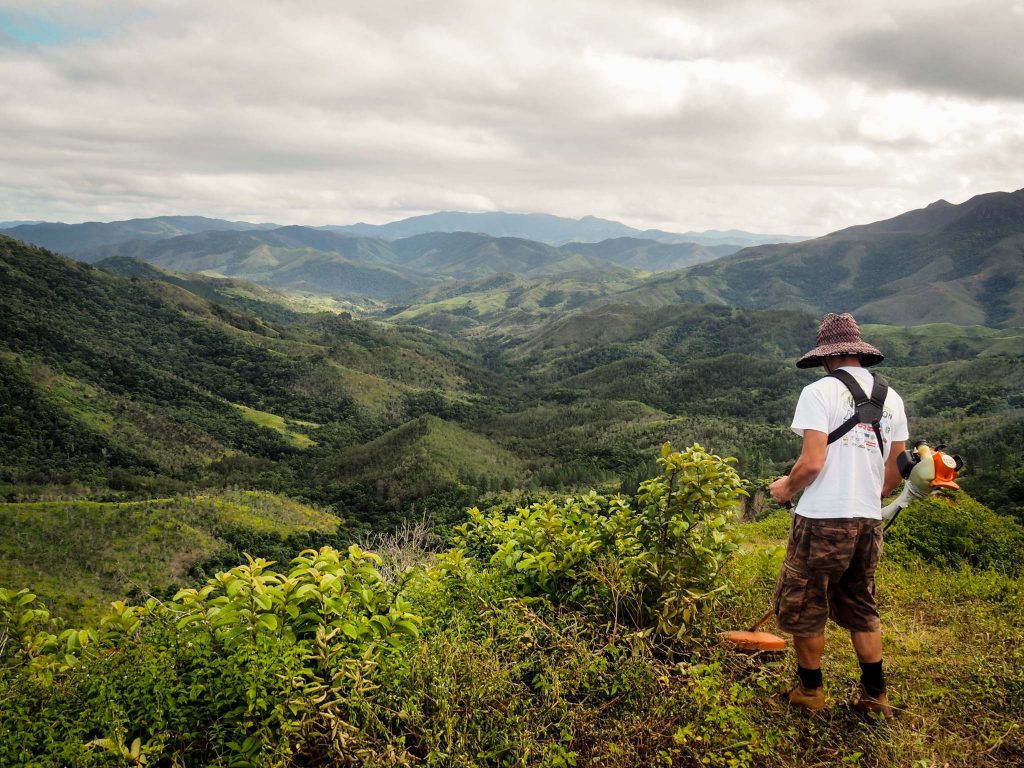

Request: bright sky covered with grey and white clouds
left=0, top=0, right=1024, bottom=234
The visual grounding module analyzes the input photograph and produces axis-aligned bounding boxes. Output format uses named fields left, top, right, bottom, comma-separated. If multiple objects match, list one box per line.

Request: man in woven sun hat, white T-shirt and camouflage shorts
left=770, top=313, right=909, bottom=719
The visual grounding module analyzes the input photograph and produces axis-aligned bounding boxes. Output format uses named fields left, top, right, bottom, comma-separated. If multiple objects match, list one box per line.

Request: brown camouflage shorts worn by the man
left=774, top=515, right=882, bottom=637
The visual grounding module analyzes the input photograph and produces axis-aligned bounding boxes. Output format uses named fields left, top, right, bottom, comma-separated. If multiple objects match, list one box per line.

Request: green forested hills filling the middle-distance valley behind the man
left=6, top=232, right=1024, bottom=511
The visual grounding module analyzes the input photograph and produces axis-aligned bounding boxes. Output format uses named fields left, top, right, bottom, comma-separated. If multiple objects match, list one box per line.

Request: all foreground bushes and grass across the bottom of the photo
left=0, top=460, right=1024, bottom=768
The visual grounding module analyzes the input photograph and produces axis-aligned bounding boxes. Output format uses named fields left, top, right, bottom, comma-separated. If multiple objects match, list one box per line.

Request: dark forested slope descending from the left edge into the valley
left=0, top=231, right=516, bottom=514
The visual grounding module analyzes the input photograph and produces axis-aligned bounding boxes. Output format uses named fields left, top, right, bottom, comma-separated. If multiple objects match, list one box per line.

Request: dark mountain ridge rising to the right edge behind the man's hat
left=623, top=189, right=1024, bottom=328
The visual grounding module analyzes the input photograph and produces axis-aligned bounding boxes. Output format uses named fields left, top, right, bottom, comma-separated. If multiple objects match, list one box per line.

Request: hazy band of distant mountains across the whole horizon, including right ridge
left=7, top=189, right=1024, bottom=327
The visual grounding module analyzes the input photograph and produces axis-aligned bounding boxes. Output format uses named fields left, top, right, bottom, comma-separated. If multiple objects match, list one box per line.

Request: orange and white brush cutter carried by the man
left=719, top=440, right=964, bottom=656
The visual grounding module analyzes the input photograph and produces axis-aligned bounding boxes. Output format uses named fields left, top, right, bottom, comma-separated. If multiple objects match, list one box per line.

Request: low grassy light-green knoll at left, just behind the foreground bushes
left=0, top=492, right=340, bottom=618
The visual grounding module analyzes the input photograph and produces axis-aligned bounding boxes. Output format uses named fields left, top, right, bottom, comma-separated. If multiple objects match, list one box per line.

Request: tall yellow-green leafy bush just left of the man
left=456, top=443, right=745, bottom=639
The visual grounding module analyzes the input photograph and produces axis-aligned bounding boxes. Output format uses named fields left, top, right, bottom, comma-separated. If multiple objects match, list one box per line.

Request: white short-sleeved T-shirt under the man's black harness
left=793, top=366, right=910, bottom=520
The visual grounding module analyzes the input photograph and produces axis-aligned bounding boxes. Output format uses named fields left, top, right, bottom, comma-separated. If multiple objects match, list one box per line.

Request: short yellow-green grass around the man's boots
left=731, top=497, right=1024, bottom=767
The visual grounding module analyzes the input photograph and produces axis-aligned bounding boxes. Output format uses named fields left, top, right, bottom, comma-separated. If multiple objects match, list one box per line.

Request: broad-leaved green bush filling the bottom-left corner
left=0, top=547, right=421, bottom=766
